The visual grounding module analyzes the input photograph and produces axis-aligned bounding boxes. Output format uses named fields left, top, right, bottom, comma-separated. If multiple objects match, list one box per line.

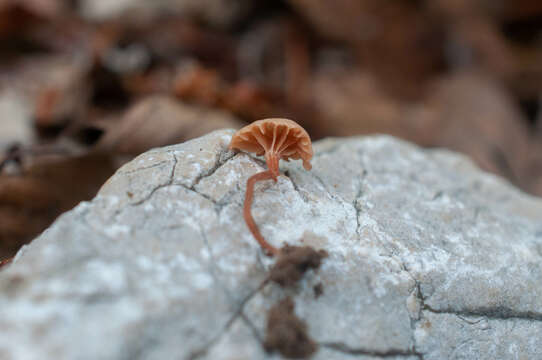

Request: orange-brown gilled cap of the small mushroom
left=230, top=118, right=313, bottom=170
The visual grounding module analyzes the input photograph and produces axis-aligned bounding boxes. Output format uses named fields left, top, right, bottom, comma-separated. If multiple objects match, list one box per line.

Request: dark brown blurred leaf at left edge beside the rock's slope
left=0, top=154, right=115, bottom=258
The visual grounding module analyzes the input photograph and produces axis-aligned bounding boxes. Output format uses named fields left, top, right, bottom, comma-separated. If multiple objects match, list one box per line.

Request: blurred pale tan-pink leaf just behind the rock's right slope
left=425, top=73, right=529, bottom=186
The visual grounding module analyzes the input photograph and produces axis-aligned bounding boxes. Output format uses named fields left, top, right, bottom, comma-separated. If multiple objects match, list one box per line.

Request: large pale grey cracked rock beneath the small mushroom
left=0, top=130, right=542, bottom=360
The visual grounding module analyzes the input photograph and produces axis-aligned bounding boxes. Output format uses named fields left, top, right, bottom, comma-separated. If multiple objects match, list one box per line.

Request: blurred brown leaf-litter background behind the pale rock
left=0, top=0, right=542, bottom=259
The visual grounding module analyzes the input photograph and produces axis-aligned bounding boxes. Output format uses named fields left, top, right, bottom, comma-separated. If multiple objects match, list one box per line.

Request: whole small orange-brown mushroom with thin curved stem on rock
left=230, top=118, right=313, bottom=256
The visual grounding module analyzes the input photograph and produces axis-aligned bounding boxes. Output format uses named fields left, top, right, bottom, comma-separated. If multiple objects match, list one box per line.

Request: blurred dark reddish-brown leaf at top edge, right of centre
left=289, top=0, right=444, bottom=97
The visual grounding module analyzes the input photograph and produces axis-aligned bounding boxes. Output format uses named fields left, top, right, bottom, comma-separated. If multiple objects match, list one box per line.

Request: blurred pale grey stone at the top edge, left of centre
left=78, top=0, right=250, bottom=26
